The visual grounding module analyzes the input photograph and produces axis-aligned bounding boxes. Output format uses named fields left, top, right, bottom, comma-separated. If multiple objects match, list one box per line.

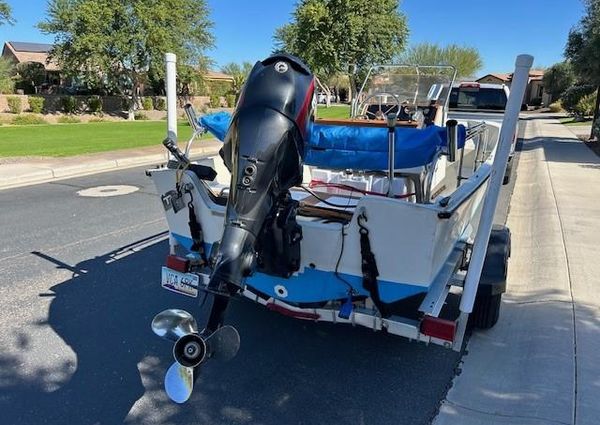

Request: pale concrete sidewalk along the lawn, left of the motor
left=0, top=139, right=222, bottom=190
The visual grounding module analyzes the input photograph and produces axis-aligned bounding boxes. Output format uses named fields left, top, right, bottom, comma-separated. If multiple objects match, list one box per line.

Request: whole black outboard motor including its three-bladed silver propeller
left=152, top=55, right=314, bottom=403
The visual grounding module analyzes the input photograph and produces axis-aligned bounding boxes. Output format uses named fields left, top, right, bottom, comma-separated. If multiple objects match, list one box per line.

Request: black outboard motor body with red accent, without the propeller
left=209, top=54, right=314, bottom=294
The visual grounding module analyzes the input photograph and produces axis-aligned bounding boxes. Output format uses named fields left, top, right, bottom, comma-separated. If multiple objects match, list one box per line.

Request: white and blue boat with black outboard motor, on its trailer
left=147, top=54, right=532, bottom=403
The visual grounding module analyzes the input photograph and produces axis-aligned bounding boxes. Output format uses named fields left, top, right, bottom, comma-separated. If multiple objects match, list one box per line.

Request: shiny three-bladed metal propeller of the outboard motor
left=152, top=309, right=240, bottom=403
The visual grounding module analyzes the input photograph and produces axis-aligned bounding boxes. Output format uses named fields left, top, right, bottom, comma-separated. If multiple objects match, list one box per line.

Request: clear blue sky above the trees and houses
left=0, top=0, right=584, bottom=75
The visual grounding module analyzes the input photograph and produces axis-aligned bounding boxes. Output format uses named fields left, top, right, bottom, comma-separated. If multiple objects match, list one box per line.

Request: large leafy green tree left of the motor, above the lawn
left=38, top=0, right=213, bottom=119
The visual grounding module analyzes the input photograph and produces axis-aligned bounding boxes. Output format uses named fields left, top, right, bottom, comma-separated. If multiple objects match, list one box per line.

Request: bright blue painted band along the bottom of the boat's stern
left=172, top=233, right=428, bottom=303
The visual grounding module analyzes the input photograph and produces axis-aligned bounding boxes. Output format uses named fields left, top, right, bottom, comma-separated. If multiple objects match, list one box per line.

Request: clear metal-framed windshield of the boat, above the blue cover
left=358, top=65, right=456, bottom=115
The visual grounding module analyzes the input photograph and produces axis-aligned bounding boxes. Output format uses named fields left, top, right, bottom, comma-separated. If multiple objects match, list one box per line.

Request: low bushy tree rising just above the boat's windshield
left=398, top=43, right=483, bottom=78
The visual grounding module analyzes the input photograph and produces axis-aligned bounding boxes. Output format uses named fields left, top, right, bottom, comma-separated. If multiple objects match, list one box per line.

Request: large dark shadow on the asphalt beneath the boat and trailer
left=0, top=235, right=460, bottom=425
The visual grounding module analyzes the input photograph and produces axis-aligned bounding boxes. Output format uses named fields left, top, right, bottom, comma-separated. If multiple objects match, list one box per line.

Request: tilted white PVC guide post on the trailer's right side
left=460, top=55, right=533, bottom=316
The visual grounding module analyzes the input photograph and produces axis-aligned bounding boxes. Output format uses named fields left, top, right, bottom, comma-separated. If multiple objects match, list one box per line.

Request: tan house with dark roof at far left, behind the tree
left=2, top=41, right=61, bottom=91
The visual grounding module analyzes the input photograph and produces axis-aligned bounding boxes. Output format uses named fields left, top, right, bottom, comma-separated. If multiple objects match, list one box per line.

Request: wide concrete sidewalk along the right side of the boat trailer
left=433, top=117, right=600, bottom=425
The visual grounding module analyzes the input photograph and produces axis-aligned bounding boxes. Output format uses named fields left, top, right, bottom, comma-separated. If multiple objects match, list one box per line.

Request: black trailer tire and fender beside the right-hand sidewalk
left=469, top=225, right=510, bottom=329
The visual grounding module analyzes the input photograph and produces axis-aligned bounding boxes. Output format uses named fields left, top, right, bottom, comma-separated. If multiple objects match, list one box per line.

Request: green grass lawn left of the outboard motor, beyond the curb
left=0, top=121, right=210, bottom=157
